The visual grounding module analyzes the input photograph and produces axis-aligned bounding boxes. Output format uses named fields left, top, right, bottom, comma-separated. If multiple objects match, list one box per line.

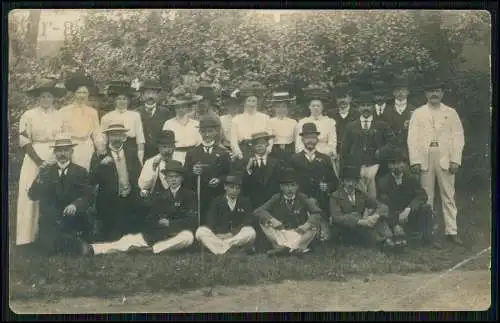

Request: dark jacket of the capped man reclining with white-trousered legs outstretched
left=147, top=186, right=197, bottom=234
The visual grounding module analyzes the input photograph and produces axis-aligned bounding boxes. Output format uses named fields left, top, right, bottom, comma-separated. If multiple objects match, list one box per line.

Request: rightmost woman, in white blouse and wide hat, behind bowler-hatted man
left=295, top=85, right=337, bottom=173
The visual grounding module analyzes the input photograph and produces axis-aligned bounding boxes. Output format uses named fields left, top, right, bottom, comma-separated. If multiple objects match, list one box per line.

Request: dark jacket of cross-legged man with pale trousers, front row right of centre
left=254, top=192, right=323, bottom=229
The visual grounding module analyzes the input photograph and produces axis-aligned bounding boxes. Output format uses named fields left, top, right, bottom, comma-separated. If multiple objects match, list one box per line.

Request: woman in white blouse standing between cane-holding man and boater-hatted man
left=231, top=81, right=273, bottom=161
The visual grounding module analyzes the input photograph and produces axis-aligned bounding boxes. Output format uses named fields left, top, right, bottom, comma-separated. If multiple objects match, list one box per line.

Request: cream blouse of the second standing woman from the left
left=59, top=103, right=101, bottom=140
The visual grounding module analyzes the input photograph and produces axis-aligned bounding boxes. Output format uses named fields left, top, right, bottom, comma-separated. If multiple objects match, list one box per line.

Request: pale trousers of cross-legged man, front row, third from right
left=260, top=224, right=317, bottom=250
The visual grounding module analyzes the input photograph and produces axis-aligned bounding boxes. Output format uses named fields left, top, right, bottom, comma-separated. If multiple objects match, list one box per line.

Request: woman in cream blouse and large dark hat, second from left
left=59, top=74, right=105, bottom=170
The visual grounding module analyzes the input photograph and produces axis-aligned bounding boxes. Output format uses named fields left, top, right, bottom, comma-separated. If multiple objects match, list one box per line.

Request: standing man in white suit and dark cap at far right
left=408, top=83, right=464, bottom=244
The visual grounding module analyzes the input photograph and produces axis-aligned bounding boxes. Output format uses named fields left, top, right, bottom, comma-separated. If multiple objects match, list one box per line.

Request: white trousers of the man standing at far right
left=420, top=147, right=457, bottom=234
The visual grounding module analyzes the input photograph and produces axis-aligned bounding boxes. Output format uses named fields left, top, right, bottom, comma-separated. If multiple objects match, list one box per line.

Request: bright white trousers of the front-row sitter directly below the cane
left=195, top=226, right=257, bottom=255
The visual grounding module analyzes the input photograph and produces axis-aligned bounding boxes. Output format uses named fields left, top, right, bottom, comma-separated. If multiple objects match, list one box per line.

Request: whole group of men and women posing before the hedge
left=17, top=75, right=464, bottom=255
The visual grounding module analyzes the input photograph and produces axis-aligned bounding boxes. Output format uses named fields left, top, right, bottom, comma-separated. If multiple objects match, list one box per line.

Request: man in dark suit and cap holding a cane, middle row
left=184, top=117, right=231, bottom=224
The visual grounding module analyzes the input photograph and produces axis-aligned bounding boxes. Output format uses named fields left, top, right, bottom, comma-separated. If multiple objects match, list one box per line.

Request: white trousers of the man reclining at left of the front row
left=91, top=230, right=194, bottom=255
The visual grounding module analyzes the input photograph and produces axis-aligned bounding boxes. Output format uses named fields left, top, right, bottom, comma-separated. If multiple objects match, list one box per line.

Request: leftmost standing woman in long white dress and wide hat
left=16, top=80, right=66, bottom=245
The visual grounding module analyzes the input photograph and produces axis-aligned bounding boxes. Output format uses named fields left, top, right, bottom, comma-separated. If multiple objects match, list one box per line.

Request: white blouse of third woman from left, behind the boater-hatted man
left=101, top=110, right=146, bottom=145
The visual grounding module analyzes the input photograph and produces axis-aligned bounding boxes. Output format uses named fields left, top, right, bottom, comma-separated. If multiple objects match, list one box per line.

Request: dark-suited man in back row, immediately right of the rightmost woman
left=330, top=83, right=359, bottom=156
